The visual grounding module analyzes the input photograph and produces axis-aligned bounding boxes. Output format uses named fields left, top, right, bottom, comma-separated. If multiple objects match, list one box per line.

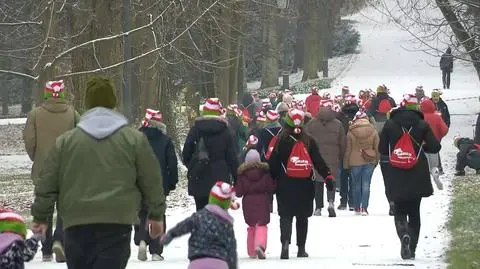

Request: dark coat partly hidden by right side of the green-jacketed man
left=140, top=124, right=178, bottom=196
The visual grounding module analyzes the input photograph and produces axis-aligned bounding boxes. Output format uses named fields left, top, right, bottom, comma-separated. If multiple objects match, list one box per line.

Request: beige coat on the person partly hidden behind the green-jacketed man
left=23, top=99, right=80, bottom=184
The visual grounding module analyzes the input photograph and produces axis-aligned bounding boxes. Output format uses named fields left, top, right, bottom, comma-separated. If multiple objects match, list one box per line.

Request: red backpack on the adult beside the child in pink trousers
left=284, top=136, right=312, bottom=178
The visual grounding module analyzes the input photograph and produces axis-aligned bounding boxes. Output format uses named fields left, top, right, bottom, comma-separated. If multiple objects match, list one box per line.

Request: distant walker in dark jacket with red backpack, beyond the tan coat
left=368, top=85, right=397, bottom=133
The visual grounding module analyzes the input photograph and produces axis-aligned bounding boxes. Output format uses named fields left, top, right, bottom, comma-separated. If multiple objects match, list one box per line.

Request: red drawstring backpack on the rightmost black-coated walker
left=390, top=126, right=423, bottom=169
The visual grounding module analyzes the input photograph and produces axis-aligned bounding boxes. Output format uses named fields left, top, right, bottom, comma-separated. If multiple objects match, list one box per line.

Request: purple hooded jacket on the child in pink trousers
left=235, top=162, right=275, bottom=226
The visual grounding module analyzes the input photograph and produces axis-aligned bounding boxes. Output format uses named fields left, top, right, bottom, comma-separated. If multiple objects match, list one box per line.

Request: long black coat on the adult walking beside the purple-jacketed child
left=268, top=131, right=330, bottom=217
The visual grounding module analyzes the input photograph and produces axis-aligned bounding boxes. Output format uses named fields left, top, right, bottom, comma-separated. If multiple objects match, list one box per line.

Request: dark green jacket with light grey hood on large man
left=31, top=108, right=166, bottom=229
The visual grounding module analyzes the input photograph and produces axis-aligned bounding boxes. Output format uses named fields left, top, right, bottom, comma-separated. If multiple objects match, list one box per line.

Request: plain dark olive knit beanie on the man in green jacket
left=85, top=77, right=117, bottom=110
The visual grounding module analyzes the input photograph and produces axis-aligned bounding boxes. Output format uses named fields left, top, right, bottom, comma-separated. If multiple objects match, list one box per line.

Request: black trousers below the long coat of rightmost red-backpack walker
left=395, top=198, right=422, bottom=253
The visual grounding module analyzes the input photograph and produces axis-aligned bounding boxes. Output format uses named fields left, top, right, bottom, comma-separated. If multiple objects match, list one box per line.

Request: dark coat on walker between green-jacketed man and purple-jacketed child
left=182, top=117, right=238, bottom=197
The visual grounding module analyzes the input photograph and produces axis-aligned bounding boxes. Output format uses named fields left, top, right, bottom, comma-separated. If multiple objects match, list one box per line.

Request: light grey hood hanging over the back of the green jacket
left=77, top=107, right=128, bottom=140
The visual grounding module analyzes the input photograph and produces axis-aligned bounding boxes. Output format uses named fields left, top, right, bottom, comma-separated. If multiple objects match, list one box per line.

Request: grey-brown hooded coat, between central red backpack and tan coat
left=305, top=108, right=347, bottom=178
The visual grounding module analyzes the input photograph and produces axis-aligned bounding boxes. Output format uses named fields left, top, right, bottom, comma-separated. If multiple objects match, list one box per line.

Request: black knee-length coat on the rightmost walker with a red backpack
left=378, top=108, right=441, bottom=201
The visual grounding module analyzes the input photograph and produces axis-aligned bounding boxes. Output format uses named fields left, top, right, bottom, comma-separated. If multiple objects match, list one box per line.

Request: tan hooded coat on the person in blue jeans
left=343, top=119, right=380, bottom=169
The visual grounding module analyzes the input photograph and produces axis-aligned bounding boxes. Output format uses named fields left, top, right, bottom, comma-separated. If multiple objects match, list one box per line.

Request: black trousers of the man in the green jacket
left=65, top=224, right=132, bottom=269
